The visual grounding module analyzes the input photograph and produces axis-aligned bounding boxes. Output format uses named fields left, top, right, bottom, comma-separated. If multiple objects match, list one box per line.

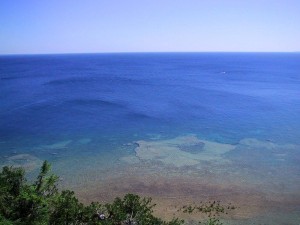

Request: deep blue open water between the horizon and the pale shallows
left=0, top=53, right=300, bottom=148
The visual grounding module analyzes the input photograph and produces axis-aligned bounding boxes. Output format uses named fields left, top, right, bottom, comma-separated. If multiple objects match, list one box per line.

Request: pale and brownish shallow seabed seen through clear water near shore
left=1, top=135, right=300, bottom=224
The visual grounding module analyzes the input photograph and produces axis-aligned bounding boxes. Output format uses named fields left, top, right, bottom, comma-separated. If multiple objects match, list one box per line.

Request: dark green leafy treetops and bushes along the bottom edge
left=0, top=161, right=232, bottom=225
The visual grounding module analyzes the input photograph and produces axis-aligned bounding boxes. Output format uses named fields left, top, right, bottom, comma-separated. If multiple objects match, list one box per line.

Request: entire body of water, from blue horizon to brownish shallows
left=0, top=53, right=300, bottom=224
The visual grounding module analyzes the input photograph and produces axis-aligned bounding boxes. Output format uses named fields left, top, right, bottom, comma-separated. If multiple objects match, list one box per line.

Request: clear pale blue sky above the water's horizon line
left=0, top=0, right=300, bottom=54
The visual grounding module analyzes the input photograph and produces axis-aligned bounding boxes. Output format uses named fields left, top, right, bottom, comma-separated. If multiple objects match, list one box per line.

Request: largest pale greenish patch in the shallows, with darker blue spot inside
left=121, top=135, right=235, bottom=167
